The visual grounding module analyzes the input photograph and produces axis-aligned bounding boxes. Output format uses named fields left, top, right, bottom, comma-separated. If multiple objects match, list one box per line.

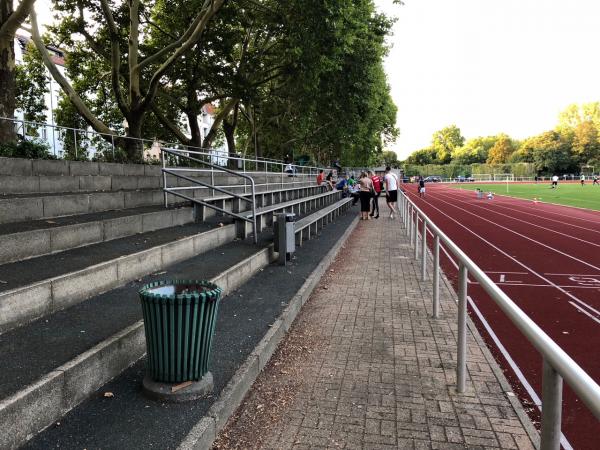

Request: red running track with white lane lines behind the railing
left=405, top=184, right=600, bottom=450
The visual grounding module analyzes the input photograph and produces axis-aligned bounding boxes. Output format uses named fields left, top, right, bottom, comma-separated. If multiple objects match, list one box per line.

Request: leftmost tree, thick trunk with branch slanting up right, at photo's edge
left=0, top=0, right=35, bottom=142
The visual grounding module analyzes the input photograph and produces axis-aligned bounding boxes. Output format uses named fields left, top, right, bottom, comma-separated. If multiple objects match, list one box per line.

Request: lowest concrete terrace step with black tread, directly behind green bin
left=0, top=234, right=272, bottom=448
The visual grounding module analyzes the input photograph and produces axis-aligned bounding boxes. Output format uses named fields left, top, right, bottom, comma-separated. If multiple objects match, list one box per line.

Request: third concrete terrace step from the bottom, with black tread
left=0, top=206, right=194, bottom=264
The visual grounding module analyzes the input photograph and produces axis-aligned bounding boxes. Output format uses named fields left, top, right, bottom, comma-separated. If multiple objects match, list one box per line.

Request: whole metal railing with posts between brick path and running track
left=398, top=191, right=600, bottom=450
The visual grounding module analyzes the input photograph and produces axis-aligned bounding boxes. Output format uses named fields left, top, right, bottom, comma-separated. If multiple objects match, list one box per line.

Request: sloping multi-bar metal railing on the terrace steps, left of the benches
left=161, top=148, right=258, bottom=244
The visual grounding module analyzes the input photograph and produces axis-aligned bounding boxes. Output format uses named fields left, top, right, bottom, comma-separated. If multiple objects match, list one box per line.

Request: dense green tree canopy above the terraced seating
left=8, top=0, right=398, bottom=165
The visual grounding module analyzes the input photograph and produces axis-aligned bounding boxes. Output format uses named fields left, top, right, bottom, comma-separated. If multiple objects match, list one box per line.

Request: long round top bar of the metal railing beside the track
left=402, top=192, right=600, bottom=419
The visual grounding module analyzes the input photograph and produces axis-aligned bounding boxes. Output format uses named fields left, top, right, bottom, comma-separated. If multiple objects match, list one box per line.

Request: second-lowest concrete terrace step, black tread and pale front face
left=0, top=221, right=235, bottom=332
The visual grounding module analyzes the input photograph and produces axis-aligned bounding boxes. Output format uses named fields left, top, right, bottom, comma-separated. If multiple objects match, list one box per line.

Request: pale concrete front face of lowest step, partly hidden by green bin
left=0, top=246, right=275, bottom=449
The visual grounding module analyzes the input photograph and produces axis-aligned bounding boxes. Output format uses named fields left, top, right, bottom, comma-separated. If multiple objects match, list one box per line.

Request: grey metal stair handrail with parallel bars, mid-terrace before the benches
left=160, top=147, right=258, bottom=244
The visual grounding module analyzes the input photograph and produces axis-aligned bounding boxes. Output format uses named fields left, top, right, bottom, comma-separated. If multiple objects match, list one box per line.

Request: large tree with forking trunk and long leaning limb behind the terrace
left=30, top=0, right=225, bottom=161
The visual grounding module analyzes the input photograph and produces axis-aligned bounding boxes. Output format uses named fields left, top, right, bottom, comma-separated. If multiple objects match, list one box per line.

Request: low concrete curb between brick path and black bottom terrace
left=178, top=217, right=358, bottom=450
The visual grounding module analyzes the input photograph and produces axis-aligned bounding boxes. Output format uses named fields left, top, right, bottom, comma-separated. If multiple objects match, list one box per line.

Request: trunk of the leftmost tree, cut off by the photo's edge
left=0, top=30, right=17, bottom=143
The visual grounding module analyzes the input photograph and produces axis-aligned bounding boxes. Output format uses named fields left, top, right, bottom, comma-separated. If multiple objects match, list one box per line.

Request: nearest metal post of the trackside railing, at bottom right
left=540, top=358, right=563, bottom=450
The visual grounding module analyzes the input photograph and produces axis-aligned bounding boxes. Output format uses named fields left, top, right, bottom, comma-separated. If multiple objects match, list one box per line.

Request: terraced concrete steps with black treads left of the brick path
left=0, top=158, right=353, bottom=448
